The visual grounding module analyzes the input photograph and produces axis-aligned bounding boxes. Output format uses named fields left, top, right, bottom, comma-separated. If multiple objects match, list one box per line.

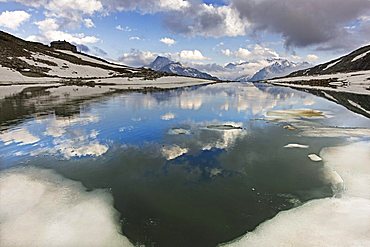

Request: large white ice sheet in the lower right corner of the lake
left=224, top=142, right=370, bottom=247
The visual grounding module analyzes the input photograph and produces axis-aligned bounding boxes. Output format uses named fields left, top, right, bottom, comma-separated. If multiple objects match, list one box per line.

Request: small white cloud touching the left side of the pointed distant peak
left=118, top=49, right=157, bottom=67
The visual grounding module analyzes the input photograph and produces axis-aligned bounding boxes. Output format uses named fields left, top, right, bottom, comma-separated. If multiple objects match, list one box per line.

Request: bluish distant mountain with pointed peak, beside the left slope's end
left=147, top=56, right=218, bottom=80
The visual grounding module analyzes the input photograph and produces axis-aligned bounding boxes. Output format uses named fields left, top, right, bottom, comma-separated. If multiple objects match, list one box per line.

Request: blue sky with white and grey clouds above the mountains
left=0, top=0, right=370, bottom=78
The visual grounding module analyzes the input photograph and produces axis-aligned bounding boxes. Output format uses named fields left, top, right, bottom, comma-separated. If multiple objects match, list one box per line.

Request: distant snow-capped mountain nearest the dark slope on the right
left=248, top=59, right=311, bottom=82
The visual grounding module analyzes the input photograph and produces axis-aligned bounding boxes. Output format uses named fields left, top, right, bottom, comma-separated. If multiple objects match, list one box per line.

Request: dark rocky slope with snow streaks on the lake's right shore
left=289, top=45, right=370, bottom=77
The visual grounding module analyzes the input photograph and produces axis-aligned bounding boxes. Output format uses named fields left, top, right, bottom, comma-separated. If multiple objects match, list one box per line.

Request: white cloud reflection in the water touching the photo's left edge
left=0, top=128, right=40, bottom=145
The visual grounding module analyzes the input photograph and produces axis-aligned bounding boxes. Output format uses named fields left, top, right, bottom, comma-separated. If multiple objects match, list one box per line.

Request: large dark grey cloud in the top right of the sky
left=231, top=0, right=370, bottom=47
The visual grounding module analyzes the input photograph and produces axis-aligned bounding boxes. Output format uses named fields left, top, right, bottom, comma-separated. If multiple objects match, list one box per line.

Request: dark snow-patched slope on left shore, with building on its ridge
left=0, top=31, right=166, bottom=81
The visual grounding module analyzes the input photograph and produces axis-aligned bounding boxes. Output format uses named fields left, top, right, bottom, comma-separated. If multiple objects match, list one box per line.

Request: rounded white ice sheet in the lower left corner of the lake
left=0, top=168, right=132, bottom=247
